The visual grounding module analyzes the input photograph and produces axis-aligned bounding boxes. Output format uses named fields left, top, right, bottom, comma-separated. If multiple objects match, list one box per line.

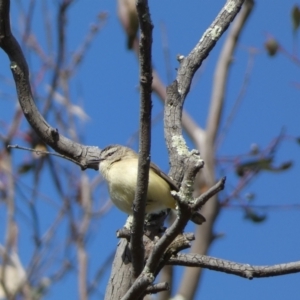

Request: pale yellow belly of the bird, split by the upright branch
left=105, top=159, right=176, bottom=214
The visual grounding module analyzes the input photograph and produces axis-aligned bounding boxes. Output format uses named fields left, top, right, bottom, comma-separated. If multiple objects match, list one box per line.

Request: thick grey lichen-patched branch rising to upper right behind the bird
left=165, top=0, right=244, bottom=183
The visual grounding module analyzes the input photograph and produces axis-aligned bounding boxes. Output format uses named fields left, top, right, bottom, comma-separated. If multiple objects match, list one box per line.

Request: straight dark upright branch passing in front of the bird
left=130, top=0, right=153, bottom=278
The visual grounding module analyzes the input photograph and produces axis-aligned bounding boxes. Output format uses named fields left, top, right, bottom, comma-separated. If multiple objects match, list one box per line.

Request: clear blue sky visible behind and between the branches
left=0, top=0, right=300, bottom=300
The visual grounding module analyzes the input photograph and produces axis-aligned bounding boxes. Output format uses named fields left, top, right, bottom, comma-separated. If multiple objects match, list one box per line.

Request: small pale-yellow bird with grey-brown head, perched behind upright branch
left=91, top=145, right=205, bottom=225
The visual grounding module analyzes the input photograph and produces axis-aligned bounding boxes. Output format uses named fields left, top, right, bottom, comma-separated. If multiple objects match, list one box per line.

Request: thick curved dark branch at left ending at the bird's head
left=0, top=0, right=100, bottom=169
